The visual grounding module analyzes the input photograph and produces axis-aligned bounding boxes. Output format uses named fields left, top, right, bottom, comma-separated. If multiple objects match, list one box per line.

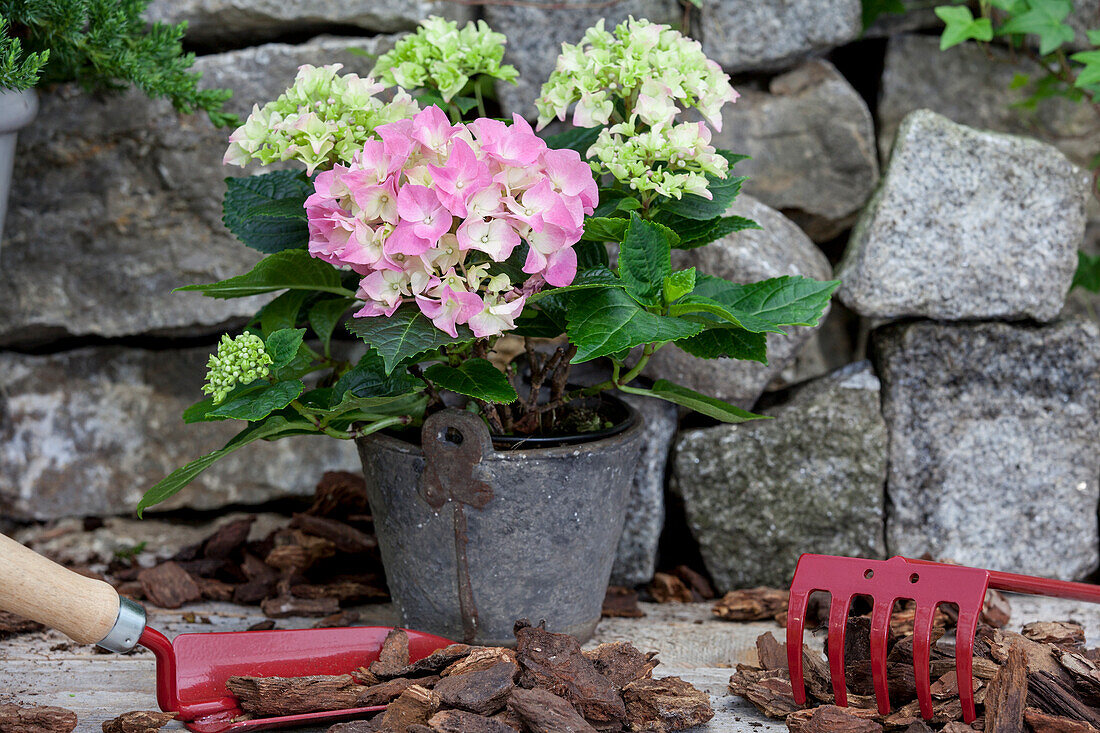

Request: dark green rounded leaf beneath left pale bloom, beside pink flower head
left=222, top=171, right=314, bottom=254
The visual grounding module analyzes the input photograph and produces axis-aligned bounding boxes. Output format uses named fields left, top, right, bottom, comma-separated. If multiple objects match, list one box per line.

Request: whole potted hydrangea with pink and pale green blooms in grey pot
left=140, top=19, right=836, bottom=643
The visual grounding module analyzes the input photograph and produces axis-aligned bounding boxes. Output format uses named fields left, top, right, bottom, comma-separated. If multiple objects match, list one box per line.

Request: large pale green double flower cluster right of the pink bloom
left=535, top=18, right=738, bottom=198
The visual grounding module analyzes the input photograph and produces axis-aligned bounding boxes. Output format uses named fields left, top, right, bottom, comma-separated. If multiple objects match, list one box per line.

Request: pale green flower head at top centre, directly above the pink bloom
left=371, top=15, right=517, bottom=101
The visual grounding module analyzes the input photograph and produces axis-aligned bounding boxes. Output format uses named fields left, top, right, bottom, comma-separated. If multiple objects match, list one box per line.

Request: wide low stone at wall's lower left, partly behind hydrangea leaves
left=0, top=347, right=360, bottom=519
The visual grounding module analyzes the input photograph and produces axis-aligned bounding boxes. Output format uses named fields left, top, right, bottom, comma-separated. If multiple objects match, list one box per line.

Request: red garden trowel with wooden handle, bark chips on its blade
left=0, top=535, right=451, bottom=733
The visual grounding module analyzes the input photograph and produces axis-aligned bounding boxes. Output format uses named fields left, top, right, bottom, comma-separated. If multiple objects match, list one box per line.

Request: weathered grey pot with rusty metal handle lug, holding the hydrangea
left=358, top=401, right=644, bottom=645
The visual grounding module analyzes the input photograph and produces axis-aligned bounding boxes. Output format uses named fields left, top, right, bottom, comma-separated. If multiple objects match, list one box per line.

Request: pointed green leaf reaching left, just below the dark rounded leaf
left=176, top=250, right=355, bottom=298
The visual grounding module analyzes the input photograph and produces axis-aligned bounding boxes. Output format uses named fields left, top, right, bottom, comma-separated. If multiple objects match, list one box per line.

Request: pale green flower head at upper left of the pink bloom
left=223, top=64, right=419, bottom=175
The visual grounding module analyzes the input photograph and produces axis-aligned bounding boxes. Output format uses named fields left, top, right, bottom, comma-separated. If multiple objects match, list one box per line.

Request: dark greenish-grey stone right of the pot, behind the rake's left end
left=672, top=362, right=887, bottom=591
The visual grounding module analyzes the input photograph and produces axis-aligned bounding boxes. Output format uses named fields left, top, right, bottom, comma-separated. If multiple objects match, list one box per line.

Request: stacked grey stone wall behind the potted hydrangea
left=0, top=0, right=1100, bottom=589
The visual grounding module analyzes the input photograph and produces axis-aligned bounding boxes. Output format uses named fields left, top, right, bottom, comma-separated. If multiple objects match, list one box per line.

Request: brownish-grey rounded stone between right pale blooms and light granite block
left=714, top=61, right=879, bottom=241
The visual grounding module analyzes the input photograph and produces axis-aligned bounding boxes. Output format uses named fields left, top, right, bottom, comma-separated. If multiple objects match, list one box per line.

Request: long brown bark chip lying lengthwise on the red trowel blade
left=226, top=675, right=363, bottom=718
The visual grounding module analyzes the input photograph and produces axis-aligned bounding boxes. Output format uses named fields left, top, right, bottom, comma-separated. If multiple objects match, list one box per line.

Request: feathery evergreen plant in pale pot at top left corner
left=0, top=0, right=240, bottom=238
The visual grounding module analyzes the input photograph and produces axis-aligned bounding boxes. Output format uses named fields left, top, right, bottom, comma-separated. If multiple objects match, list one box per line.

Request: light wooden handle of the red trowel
left=0, top=535, right=123, bottom=644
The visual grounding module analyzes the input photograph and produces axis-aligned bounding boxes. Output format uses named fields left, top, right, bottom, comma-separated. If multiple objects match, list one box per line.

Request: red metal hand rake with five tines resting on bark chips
left=787, top=555, right=1100, bottom=723
